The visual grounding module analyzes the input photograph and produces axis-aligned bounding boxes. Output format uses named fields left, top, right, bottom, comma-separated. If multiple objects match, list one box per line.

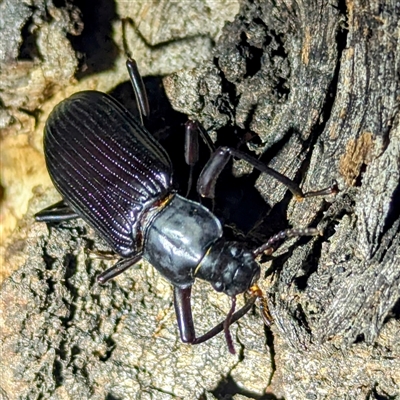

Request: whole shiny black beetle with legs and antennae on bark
left=35, top=59, right=336, bottom=353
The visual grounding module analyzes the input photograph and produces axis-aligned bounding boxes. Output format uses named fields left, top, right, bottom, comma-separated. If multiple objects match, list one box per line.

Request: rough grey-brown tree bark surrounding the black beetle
left=0, top=0, right=400, bottom=400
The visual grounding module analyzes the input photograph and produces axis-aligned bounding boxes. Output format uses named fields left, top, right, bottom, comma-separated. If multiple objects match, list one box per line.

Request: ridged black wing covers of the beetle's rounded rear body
left=44, top=91, right=172, bottom=257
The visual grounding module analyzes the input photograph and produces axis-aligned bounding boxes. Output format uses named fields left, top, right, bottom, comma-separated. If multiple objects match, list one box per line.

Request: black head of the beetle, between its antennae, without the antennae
left=196, top=240, right=260, bottom=296
